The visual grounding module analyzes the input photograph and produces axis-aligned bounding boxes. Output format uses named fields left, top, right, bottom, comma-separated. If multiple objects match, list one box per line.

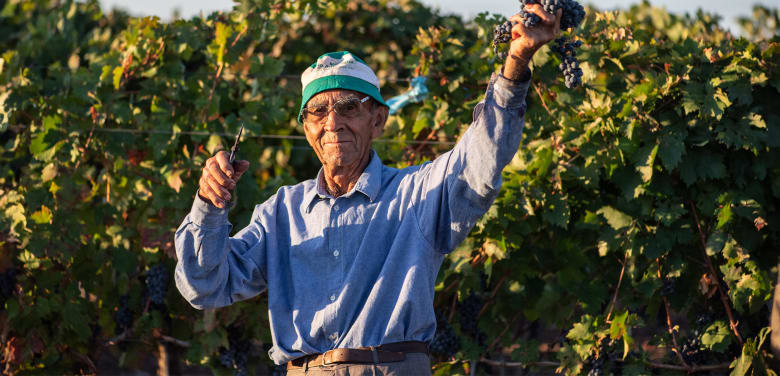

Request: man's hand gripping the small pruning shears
left=198, top=150, right=249, bottom=209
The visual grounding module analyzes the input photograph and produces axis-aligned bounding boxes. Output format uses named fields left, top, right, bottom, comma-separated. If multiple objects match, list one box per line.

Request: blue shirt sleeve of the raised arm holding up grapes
left=412, top=74, right=530, bottom=253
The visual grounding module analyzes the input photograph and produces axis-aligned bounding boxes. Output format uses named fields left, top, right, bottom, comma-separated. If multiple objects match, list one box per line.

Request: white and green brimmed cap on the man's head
left=298, top=51, right=387, bottom=123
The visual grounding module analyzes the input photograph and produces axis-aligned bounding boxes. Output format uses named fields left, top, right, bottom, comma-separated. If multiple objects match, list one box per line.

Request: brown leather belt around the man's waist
left=287, top=341, right=428, bottom=370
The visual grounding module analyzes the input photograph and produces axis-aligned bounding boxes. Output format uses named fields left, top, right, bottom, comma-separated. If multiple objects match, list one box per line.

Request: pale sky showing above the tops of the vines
left=100, top=0, right=780, bottom=33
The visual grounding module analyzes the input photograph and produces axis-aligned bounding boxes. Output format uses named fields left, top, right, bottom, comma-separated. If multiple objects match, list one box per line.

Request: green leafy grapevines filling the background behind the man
left=0, top=0, right=780, bottom=375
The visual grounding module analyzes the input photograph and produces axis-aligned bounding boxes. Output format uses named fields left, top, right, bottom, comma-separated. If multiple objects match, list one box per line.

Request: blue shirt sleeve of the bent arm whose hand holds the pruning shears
left=175, top=195, right=267, bottom=309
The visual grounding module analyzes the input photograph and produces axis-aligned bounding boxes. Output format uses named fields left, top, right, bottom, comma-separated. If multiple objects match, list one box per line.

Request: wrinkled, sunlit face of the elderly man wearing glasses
left=303, top=89, right=387, bottom=167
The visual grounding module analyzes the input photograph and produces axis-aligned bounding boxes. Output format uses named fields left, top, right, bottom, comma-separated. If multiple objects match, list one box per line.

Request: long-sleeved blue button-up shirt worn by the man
left=175, top=75, right=529, bottom=364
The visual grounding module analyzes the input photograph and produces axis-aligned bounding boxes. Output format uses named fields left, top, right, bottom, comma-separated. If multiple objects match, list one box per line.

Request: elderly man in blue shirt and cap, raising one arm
left=176, top=4, right=561, bottom=375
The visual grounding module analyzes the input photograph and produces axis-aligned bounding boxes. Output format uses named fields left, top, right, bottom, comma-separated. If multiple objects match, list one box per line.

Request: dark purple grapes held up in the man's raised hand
left=493, top=0, right=585, bottom=89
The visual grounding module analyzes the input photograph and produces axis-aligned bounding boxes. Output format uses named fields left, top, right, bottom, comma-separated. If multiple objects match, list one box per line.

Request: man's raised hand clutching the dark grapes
left=504, top=4, right=563, bottom=80
